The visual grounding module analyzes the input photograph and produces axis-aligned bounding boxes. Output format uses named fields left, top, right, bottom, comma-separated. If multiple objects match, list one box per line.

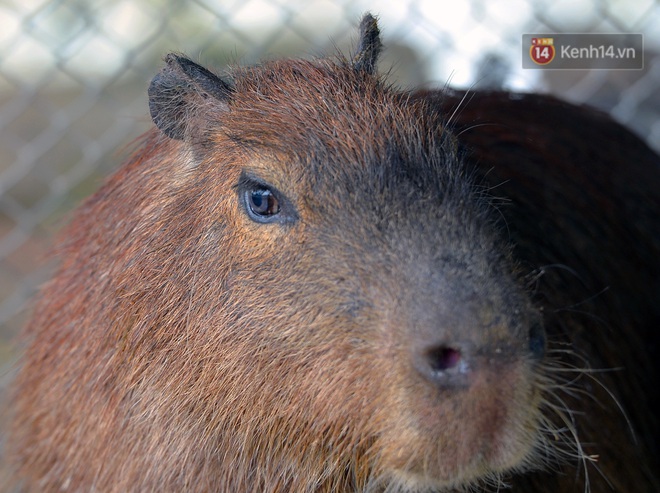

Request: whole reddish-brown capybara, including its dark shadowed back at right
left=7, top=15, right=660, bottom=493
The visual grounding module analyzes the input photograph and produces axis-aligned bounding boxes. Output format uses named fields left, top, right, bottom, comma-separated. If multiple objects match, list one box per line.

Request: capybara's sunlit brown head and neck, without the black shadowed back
left=10, top=16, right=545, bottom=492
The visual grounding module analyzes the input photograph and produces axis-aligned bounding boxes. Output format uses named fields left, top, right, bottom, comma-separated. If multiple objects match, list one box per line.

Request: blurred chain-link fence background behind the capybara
left=0, top=0, right=660, bottom=389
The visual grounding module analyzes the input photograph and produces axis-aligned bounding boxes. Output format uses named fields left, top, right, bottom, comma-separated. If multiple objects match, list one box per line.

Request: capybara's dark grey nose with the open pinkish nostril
left=405, top=294, right=546, bottom=388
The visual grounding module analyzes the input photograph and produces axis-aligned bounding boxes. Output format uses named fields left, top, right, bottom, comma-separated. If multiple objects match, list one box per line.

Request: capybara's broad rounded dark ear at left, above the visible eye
left=149, top=53, right=232, bottom=140
